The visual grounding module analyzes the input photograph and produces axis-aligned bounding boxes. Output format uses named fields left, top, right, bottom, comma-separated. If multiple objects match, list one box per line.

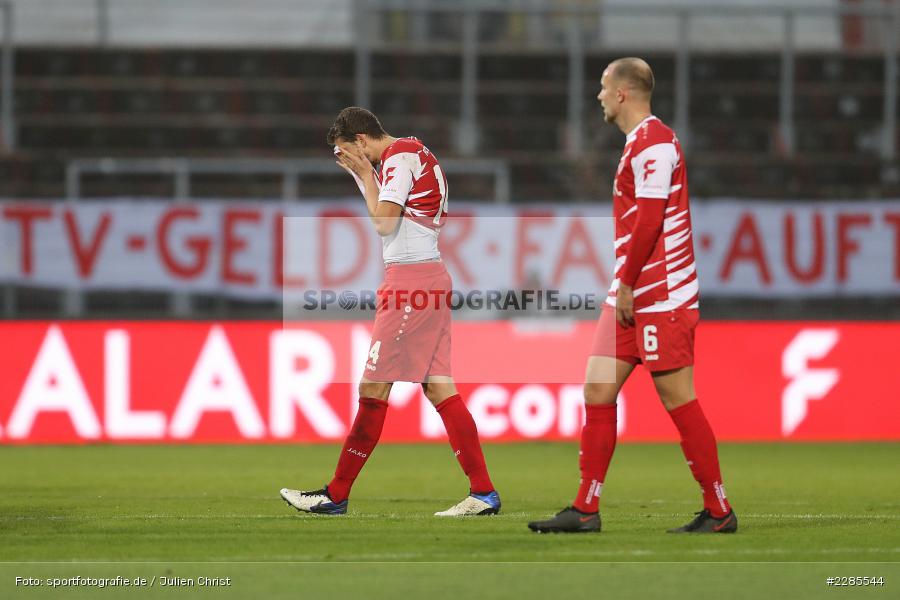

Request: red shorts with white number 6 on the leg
left=591, top=304, right=700, bottom=371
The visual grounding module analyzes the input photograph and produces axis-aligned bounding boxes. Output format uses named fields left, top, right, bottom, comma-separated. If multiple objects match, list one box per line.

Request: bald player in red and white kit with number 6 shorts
left=528, top=58, right=737, bottom=533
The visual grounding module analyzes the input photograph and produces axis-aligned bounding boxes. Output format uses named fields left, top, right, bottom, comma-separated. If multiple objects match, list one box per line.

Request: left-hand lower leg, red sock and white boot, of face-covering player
left=281, top=378, right=393, bottom=514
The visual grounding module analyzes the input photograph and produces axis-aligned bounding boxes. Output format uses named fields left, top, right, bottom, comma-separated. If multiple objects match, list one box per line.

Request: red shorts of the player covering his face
left=363, top=262, right=452, bottom=383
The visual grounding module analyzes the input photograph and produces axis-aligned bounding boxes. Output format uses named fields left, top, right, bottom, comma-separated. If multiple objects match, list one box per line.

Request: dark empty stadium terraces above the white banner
left=0, top=47, right=900, bottom=201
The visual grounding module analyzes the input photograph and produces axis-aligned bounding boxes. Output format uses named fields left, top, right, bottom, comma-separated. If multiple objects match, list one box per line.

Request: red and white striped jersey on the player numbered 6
left=606, top=115, right=700, bottom=313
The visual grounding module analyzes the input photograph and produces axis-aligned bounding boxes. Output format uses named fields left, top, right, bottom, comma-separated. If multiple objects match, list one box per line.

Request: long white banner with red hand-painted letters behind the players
left=0, top=199, right=900, bottom=300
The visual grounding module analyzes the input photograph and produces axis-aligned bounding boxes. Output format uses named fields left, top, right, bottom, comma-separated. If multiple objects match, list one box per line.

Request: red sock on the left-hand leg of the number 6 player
left=572, top=404, right=616, bottom=513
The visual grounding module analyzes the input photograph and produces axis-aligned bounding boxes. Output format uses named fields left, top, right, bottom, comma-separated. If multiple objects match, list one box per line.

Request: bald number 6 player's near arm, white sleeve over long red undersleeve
left=616, top=144, right=678, bottom=327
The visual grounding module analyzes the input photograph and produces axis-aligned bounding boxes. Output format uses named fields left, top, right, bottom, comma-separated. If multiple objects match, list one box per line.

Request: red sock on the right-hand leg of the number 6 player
left=669, top=398, right=731, bottom=519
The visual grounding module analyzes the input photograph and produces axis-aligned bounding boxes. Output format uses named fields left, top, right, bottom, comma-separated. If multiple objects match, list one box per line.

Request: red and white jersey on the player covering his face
left=375, top=137, right=447, bottom=263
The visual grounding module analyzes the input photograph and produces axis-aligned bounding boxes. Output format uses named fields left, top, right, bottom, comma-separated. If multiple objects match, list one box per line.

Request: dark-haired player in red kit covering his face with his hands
left=281, top=107, right=500, bottom=517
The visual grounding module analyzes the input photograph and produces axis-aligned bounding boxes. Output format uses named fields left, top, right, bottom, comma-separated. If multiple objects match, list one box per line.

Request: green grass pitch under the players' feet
left=0, top=443, right=900, bottom=600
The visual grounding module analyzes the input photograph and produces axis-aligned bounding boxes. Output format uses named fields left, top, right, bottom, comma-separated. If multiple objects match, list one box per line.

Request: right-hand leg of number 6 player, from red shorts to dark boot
left=648, top=311, right=737, bottom=533
